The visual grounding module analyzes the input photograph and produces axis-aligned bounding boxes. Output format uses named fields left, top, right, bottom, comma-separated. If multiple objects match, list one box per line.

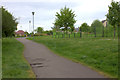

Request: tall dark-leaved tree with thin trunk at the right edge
left=107, top=0, right=120, bottom=38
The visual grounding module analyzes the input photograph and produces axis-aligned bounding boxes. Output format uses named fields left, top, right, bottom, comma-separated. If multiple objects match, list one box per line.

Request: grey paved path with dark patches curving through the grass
left=17, top=38, right=104, bottom=78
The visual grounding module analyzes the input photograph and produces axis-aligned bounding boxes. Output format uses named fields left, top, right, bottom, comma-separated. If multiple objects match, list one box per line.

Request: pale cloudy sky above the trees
left=0, top=0, right=119, bottom=32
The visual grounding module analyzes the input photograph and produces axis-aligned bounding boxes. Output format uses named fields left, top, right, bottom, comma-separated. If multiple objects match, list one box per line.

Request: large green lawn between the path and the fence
left=28, top=36, right=118, bottom=77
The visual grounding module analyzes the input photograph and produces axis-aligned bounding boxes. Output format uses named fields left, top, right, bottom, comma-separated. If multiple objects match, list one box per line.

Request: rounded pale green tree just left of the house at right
left=91, top=20, right=104, bottom=37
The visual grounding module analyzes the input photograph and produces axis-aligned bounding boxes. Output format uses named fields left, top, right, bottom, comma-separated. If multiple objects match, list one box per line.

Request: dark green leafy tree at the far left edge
left=0, top=7, right=18, bottom=37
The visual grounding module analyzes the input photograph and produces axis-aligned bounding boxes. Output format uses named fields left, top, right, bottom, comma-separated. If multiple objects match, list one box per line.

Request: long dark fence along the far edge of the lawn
left=52, top=27, right=118, bottom=38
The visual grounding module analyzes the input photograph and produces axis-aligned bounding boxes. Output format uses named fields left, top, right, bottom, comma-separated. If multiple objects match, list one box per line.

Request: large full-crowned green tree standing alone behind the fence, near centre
left=54, top=6, right=76, bottom=32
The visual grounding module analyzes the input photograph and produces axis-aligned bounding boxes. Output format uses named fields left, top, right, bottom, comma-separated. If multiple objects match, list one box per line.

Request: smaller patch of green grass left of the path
left=2, top=38, right=35, bottom=78
